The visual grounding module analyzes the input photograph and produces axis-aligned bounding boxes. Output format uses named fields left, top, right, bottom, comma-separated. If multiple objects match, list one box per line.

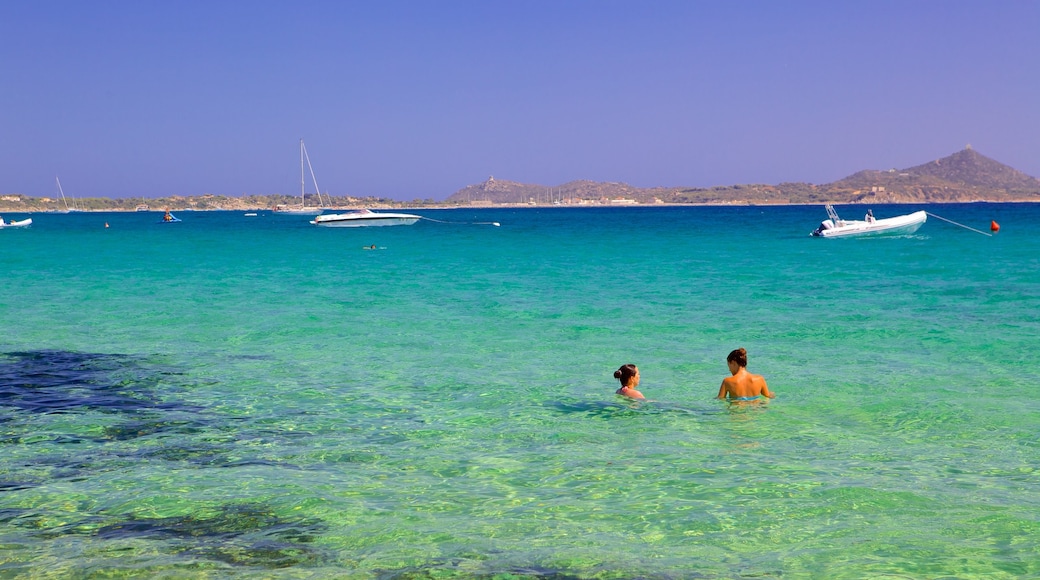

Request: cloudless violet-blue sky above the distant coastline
left=0, top=0, right=1040, bottom=200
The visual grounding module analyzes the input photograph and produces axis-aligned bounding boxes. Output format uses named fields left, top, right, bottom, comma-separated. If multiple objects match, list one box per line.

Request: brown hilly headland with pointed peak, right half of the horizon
left=446, top=147, right=1040, bottom=205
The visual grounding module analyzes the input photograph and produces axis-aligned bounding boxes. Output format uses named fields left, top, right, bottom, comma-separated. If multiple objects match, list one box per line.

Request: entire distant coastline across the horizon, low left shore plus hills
left=0, top=146, right=1040, bottom=213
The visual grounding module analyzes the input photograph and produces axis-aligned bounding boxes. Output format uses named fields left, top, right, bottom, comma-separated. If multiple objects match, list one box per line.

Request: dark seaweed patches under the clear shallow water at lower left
left=0, top=350, right=326, bottom=571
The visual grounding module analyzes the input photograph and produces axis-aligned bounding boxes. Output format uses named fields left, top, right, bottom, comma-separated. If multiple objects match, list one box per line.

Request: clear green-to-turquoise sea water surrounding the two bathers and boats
left=0, top=204, right=1040, bottom=578
